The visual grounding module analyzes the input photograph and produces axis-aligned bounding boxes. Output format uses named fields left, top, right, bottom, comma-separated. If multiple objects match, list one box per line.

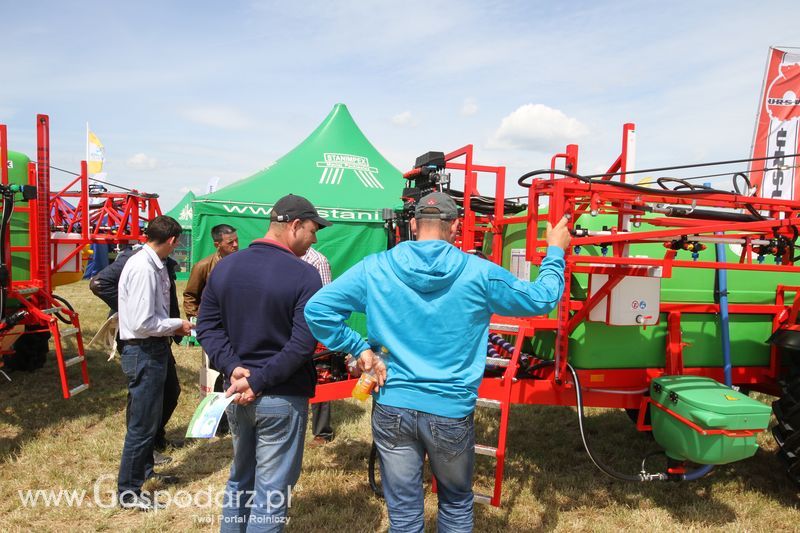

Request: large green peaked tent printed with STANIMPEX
left=192, top=104, right=404, bottom=325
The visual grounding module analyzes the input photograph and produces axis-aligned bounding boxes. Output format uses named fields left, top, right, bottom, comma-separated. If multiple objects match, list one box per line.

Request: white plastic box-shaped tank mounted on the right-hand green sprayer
left=589, top=268, right=661, bottom=326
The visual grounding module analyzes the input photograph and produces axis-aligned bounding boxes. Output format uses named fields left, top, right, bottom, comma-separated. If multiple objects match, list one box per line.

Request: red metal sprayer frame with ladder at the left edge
left=0, top=115, right=161, bottom=398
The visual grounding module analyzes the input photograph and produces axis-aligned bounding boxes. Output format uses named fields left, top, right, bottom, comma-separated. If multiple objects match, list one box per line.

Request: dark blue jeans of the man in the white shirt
left=117, top=337, right=172, bottom=497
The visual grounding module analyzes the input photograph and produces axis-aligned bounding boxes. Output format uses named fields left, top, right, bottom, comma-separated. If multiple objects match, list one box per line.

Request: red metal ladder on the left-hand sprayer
left=12, top=285, right=89, bottom=399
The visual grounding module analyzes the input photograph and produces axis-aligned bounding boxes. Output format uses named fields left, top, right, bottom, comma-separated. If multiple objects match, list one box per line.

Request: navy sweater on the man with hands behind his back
left=197, top=241, right=322, bottom=398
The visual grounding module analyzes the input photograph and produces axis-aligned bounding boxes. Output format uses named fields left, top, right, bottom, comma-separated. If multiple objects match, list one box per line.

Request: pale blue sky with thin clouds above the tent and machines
left=0, top=0, right=800, bottom=210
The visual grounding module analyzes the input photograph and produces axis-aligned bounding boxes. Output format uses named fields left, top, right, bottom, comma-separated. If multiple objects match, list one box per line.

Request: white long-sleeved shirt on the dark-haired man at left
left=118, top=245, right=183, bottom=340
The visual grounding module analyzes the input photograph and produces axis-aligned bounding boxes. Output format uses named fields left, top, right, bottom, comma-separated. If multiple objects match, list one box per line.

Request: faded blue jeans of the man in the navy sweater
left=220, top=396, right=308, bottom=532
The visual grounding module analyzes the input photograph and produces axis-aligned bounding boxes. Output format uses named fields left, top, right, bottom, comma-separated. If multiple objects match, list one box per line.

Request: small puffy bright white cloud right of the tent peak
left=488, top=104, right=589, bottom=151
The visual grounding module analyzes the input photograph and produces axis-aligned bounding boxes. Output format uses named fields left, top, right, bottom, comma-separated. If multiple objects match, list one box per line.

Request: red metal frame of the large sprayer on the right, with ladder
left=313, top=124, right=800, bottom=505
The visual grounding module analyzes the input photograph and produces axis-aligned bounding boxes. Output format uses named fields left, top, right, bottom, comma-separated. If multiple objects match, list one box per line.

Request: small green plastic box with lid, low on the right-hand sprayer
left=650, top=376, right=772, bottom=465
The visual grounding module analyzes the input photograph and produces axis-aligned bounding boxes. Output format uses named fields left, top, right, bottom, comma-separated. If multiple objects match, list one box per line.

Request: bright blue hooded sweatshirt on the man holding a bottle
left=305, top=240, right=564, bottom=418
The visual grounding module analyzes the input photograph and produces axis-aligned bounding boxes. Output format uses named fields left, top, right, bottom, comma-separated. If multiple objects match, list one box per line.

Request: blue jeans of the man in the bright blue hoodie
left=372, top=402, right=475, bottom=533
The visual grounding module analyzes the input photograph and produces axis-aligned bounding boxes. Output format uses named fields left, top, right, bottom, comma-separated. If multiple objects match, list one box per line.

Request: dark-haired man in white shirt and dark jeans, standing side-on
left=117, top=216, right=192, bottom=511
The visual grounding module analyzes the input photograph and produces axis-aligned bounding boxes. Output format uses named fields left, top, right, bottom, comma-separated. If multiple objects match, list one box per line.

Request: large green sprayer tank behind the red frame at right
left=494, top=211, right=800, bottom=369
